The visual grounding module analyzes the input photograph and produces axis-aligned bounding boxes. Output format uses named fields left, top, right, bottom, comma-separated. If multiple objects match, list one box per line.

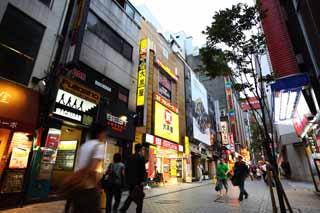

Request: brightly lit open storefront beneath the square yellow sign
left=145, top=134, right=185, bottom=183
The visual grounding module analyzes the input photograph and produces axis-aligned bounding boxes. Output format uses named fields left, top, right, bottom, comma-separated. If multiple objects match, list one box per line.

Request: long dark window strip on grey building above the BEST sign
left=87, top=12, right=133, bottom=61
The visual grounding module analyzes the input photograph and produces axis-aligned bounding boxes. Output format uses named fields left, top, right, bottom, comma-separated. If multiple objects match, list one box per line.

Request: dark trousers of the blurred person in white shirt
left=72, top=188, right=101, bottom=213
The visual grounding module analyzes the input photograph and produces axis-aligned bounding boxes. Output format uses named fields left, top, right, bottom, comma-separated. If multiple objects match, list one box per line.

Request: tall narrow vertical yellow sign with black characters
left=137, top=39, right=148, bottom=106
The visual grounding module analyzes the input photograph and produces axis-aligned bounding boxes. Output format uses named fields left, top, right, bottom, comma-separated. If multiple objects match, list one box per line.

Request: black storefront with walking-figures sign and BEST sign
left=28, top=65, right=134, bottom=199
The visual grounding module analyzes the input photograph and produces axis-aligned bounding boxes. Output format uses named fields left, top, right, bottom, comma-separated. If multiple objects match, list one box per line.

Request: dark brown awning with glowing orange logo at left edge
left=0, top=78, right=39, bottom=132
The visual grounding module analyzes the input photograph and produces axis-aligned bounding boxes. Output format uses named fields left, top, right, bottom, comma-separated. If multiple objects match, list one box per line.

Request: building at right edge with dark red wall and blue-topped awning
left=262, top=0, right=320, bottom=190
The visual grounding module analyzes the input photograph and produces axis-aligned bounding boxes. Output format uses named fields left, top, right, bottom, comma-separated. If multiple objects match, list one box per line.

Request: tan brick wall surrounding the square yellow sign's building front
left=140, top=21, right=186, bottom=142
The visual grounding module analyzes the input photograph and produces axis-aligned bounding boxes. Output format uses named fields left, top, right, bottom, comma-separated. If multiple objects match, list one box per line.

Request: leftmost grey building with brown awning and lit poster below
left=0, top=0, right=69, bottom=208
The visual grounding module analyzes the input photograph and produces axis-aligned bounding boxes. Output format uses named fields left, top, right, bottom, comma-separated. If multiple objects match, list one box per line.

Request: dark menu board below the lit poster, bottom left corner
left=1, top=170, right=25, bottom=193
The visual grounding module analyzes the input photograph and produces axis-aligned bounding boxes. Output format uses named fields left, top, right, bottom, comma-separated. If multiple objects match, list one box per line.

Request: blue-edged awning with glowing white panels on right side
left=271, top=74, right=310, bottom=123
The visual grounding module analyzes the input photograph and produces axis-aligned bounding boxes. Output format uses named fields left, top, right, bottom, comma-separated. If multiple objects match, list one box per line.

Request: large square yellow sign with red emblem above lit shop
left=154, top=102, right=179, bottom=143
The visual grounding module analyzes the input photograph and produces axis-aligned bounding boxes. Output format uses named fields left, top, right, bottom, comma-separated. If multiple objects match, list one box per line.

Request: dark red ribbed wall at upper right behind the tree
left=261, top=0, right=298, bottom=77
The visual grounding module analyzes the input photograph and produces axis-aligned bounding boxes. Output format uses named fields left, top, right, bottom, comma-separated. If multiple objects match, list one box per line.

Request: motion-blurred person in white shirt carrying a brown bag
left=61, top=124, right=107, bottom=213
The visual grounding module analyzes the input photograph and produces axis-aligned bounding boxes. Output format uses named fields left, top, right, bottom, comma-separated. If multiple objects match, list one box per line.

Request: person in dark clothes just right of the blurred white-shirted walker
left=104, top=153, right=125, bottom=213
